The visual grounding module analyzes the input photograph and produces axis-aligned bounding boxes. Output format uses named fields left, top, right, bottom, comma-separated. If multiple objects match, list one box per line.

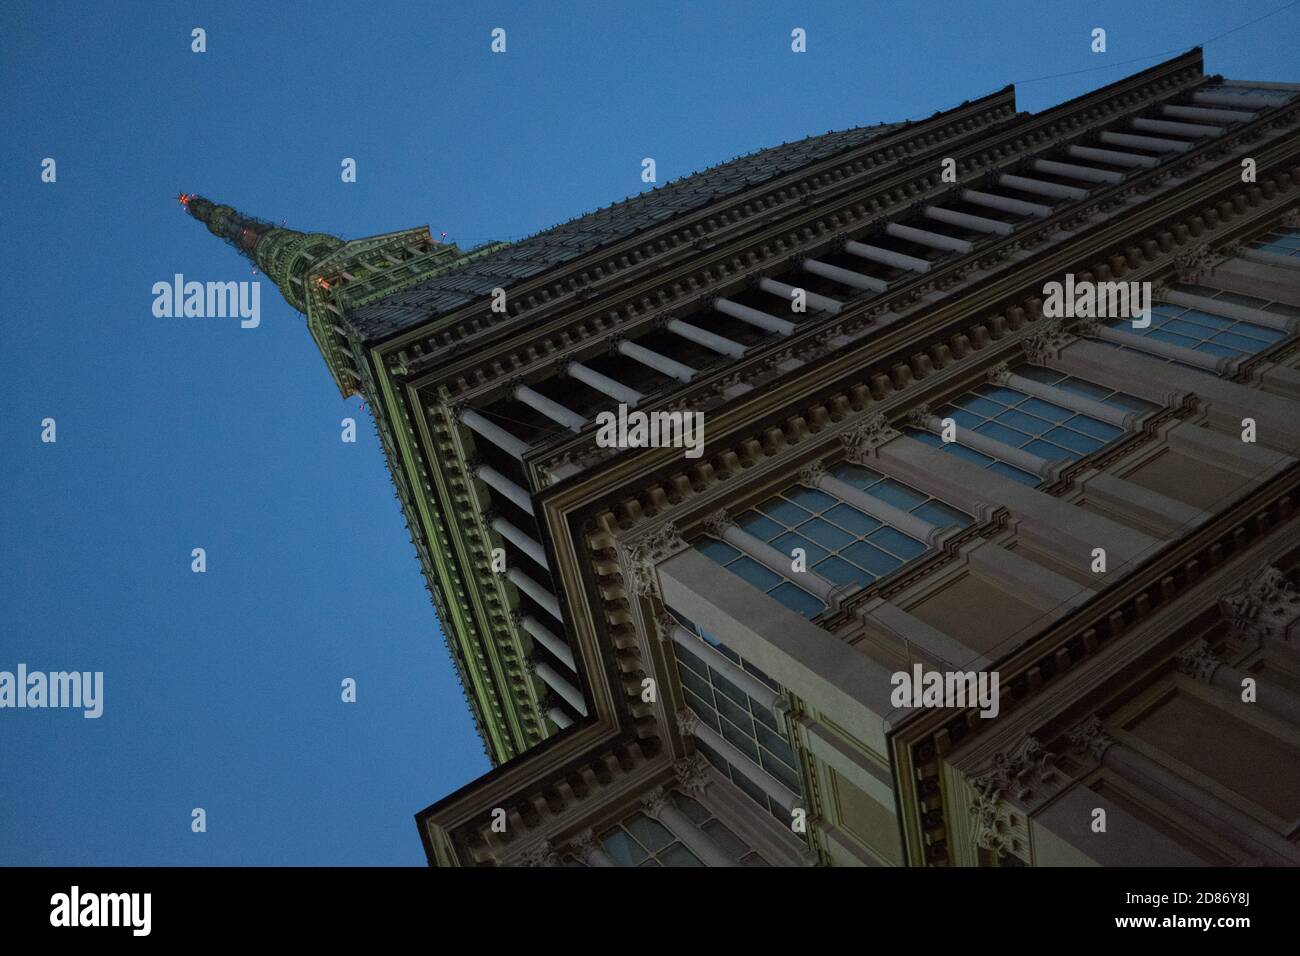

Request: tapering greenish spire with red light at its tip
left=177, top=193, right=343, bottom=313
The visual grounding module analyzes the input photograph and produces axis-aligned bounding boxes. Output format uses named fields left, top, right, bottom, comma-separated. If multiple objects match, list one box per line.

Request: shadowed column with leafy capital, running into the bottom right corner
left=1070, top=717, right=1300, bottom=866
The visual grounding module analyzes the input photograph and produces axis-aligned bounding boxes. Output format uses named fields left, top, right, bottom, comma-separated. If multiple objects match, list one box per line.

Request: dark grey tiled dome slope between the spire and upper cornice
left=350, top=124, right=902, bottom=341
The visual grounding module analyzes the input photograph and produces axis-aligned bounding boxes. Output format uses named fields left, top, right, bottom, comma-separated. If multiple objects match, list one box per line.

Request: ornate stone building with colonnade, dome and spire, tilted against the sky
left=182, top=49, right=1300, bottom=866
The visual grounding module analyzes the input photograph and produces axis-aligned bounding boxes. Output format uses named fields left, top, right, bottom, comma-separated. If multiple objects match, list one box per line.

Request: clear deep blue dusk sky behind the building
left=0, top=0, right=1300, bottom=865
